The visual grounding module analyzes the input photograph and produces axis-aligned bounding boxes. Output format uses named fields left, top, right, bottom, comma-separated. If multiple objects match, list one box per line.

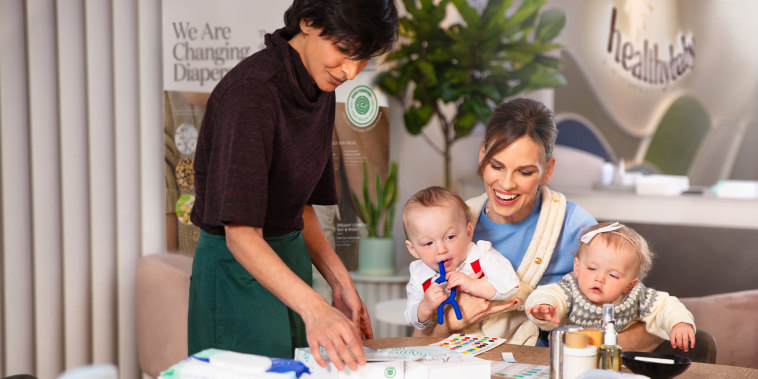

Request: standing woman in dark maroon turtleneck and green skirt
left=188, top=0, right=397, bottom=369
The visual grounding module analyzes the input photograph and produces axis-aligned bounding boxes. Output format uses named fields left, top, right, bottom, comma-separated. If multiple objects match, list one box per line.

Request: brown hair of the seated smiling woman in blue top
left=478, top=98, right=558, bottom=175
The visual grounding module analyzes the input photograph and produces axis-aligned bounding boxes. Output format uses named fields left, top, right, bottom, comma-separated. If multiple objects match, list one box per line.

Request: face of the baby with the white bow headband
left=574, top=235, right=640, bottom=305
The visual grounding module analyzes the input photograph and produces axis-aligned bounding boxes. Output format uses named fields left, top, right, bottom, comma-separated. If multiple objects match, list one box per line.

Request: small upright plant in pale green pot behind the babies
left=352, top=160, right=398, bottom=275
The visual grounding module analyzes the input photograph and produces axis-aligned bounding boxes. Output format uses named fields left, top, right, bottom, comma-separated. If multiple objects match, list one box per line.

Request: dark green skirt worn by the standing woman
left=188, top=231, right=313, bottom=359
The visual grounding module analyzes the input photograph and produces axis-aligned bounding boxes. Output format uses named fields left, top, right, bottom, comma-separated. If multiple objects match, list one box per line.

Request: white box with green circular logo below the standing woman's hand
left=295, top=347, right=405, bottom=379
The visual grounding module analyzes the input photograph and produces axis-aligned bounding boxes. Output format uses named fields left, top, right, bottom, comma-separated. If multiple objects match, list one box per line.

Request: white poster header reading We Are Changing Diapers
left=163, top=0, right=289, bottom=92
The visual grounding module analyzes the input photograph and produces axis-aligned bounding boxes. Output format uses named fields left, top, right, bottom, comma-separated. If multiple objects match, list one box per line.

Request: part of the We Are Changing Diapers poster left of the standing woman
left=162, top=0, right=288, bottom=255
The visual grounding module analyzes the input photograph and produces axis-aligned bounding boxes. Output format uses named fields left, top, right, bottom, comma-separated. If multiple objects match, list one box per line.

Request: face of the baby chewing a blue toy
left=405, top=204, right=474, bottom=273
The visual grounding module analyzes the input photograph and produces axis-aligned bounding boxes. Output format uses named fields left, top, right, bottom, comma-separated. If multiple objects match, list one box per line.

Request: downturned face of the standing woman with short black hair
left=289, top=20, right=369, bottom=92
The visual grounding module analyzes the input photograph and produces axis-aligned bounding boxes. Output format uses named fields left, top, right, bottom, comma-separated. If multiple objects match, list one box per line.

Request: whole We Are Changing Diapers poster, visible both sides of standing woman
left=162, top=0, right=389, bottom=270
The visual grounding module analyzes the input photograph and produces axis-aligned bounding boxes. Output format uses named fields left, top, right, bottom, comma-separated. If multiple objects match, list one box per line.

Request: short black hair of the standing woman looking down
left=284, top=0, right=397, bottom=60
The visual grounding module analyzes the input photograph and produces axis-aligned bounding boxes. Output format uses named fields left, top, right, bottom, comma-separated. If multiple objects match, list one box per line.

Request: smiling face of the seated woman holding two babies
left=479, top=136, right=555, bottom=223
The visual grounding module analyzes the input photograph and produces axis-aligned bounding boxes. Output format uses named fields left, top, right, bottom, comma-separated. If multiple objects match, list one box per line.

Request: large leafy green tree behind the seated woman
left=376, top=0, right=566, bottom=187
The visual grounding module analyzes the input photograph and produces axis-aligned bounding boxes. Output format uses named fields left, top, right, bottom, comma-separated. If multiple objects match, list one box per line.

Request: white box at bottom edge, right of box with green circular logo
left=405, top=357, right=492, bottom=379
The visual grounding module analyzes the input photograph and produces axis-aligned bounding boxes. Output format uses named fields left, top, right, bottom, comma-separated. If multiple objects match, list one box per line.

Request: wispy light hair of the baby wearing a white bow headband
left=576, top=222, right=655, bottom=280
